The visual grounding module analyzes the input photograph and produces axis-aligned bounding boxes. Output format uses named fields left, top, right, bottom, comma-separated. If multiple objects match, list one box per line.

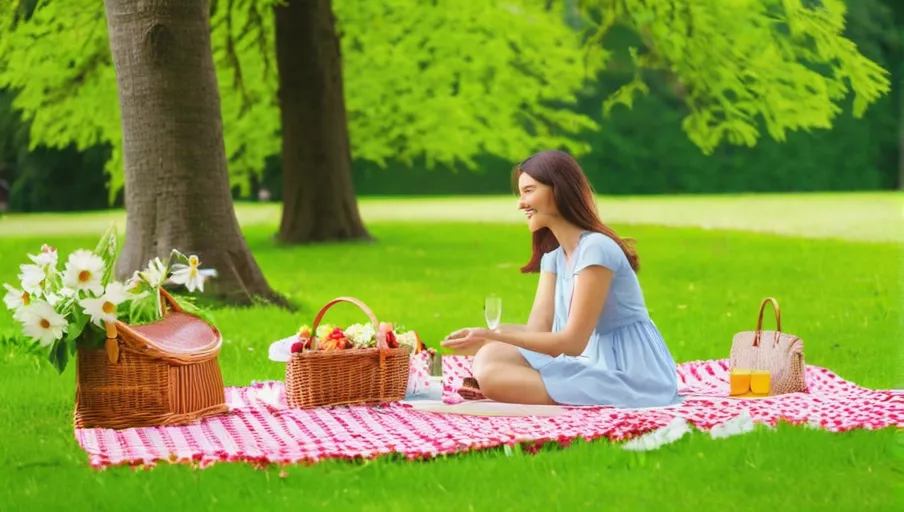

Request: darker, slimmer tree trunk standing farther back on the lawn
left=274, top=0, right=370, bottom=243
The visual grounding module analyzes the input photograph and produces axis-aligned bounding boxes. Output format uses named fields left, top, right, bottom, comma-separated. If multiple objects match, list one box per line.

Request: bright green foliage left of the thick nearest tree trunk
left=0, top=0, right=123, bottom=200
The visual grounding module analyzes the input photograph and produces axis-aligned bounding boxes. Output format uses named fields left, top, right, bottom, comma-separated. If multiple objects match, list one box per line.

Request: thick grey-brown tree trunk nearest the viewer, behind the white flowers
left=104, top=0, right=286, bottom=305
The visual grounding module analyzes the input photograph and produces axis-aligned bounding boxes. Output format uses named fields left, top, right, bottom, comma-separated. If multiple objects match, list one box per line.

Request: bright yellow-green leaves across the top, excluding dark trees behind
left=0, top=0, right=889, bottom=202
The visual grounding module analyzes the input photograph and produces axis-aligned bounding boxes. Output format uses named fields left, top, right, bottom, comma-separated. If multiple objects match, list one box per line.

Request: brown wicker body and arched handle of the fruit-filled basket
left=286, top=297, right=411, bottom=409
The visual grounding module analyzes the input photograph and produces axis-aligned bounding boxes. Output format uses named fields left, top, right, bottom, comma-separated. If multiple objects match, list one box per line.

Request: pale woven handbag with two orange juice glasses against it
left=729, top=297, right=807, bottom=396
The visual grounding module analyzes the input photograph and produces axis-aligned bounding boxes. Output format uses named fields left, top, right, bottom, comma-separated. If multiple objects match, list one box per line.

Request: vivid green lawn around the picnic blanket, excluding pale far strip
left=0, top=196, right=904, bottom=511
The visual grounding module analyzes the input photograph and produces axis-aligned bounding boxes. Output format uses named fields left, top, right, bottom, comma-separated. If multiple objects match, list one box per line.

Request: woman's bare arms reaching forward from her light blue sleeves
left=483, top=265, right=614, bottom=357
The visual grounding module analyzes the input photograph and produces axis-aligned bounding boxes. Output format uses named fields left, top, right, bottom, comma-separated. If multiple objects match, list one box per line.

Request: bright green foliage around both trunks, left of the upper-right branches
left=0, top=0, right=596, bottom=198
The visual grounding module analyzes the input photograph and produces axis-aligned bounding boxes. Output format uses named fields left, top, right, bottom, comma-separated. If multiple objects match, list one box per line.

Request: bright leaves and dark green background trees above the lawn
left=0, top=0, right=888, bottom=204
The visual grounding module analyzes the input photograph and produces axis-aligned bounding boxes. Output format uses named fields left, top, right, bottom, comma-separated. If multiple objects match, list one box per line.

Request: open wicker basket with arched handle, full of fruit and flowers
left=286, top=297, right=414, bottom=409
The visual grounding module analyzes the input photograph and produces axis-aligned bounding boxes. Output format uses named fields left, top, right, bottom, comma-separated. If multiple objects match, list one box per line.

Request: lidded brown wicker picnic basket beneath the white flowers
left=75, top=289, right=229, bottom=429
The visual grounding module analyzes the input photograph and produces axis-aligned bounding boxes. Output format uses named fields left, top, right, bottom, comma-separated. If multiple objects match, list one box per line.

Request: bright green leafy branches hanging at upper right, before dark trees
left=581, top=0, right=889, bottom=154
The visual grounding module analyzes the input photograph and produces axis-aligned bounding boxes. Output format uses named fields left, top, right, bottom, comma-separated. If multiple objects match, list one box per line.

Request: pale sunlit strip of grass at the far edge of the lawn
left=0, top=192, right=904, bottom=242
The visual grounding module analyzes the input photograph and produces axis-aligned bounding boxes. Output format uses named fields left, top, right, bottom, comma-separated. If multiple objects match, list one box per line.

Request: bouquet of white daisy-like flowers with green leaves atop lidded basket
left=3, top=226, right=215, bottom=373
